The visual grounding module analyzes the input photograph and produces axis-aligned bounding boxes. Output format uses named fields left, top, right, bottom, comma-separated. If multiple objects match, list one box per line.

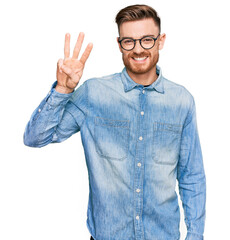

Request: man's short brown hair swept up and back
left=115, top=4, right=161, bottom=31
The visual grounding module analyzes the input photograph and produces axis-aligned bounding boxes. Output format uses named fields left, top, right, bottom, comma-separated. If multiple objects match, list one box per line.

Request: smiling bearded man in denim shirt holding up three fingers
left=24, top=5, right=206, bottom=240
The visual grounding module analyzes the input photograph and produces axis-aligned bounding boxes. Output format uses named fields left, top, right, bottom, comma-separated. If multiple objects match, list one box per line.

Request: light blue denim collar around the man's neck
left=121, top=66, right=164, bottom=93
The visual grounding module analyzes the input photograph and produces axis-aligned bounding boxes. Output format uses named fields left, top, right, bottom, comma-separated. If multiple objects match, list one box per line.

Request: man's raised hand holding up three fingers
left=55, top=32, right=93, bottom=93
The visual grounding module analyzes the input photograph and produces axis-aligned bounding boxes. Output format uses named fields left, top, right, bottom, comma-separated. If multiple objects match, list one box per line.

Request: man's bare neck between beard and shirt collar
left=126, top=66, right=158, bottom=85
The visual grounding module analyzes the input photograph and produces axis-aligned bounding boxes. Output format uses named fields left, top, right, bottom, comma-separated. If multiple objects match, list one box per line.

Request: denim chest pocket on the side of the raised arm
left=94, top=117, right=129, bottom=160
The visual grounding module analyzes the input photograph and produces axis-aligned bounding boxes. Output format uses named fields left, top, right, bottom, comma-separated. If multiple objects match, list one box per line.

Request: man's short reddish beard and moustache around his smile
left=122, top=52, right=159, bottom=74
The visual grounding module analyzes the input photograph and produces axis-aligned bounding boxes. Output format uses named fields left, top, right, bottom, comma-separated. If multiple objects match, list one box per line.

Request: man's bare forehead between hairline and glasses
left=120, top=18, right=159, bottom=38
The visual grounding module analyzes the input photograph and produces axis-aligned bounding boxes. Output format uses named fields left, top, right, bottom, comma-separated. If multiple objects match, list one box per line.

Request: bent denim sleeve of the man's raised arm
left=23, top=81, right=87, bottom=147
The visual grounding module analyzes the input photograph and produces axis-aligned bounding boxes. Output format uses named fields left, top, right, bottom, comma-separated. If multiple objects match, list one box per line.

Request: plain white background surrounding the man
left=0, top=0, right=230, bottom=240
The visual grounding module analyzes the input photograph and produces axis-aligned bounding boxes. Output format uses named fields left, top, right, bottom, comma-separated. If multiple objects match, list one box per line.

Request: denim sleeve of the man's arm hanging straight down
left=177, top=98, right=206, bottom=240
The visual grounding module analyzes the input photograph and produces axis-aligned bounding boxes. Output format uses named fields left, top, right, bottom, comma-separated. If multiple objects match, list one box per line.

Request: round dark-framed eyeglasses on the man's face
left=118, top=33, right=160, bottom=51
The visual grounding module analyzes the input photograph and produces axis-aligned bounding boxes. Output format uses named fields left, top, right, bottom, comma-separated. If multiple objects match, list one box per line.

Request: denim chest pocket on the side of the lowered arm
left=152, top=122, right=182, bottom=165
